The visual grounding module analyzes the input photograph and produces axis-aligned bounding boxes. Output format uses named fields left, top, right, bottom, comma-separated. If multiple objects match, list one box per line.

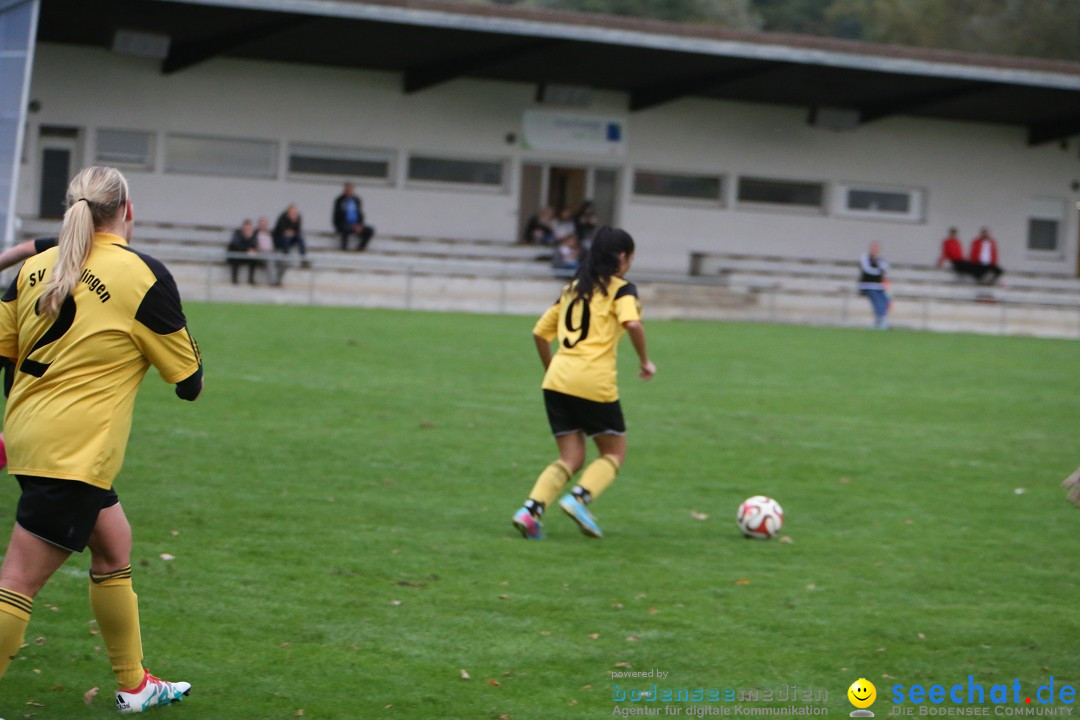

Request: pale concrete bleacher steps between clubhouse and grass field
left=18, top=218, right=1080, bottom=339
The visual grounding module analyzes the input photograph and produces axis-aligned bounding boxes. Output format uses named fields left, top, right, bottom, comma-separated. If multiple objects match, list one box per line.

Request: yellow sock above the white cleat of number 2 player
left=90, top=565, right=145, bottom=690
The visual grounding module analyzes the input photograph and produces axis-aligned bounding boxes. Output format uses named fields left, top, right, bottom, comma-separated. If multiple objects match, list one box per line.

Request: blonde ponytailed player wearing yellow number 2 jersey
left=0, top=167, right=202, bottom=712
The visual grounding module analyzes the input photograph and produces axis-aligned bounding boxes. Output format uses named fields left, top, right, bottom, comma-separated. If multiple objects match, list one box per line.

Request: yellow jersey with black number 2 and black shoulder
left=0, top=233, right=201, bottom=488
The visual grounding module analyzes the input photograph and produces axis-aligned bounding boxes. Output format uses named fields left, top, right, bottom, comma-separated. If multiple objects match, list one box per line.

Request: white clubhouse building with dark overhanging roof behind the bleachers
left=6, top=0, right=1080, bottom=276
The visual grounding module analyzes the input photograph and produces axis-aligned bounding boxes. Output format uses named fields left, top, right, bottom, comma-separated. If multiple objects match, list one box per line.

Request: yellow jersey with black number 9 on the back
left=532, top=277, right=642, bottom=403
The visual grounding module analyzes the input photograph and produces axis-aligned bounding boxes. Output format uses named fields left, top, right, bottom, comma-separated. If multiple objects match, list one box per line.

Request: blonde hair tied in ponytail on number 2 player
left=38, top=167, right=127, bottom=316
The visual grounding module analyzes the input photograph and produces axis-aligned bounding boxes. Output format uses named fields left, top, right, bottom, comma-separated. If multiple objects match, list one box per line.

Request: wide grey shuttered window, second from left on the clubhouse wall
left=165, top=135, right=278, bottom=178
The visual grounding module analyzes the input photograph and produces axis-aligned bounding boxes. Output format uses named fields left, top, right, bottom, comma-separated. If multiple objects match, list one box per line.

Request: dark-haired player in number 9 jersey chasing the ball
left=513, top=226, right=657, bottom=540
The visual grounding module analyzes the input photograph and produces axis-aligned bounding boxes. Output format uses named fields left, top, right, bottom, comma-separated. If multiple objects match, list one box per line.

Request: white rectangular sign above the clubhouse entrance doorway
left=522, top=110, right=626, bottom=155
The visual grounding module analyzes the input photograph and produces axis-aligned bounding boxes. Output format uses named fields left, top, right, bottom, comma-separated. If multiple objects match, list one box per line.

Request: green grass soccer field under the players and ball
left=0, top=304, right=1080, bottom=720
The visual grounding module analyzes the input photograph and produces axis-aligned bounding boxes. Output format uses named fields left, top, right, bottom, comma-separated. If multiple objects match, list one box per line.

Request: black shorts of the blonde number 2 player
left=15, top=475, right=120, bottom=553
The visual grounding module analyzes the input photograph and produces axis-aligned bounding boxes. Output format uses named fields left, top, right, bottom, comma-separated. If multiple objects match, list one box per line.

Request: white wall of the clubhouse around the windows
left=17, top=44, right=1080, bottom=274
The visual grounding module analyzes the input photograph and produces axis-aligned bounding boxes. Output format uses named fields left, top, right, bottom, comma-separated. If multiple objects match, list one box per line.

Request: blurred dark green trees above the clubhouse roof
left=468, top=0, right=1080, bottom=60
